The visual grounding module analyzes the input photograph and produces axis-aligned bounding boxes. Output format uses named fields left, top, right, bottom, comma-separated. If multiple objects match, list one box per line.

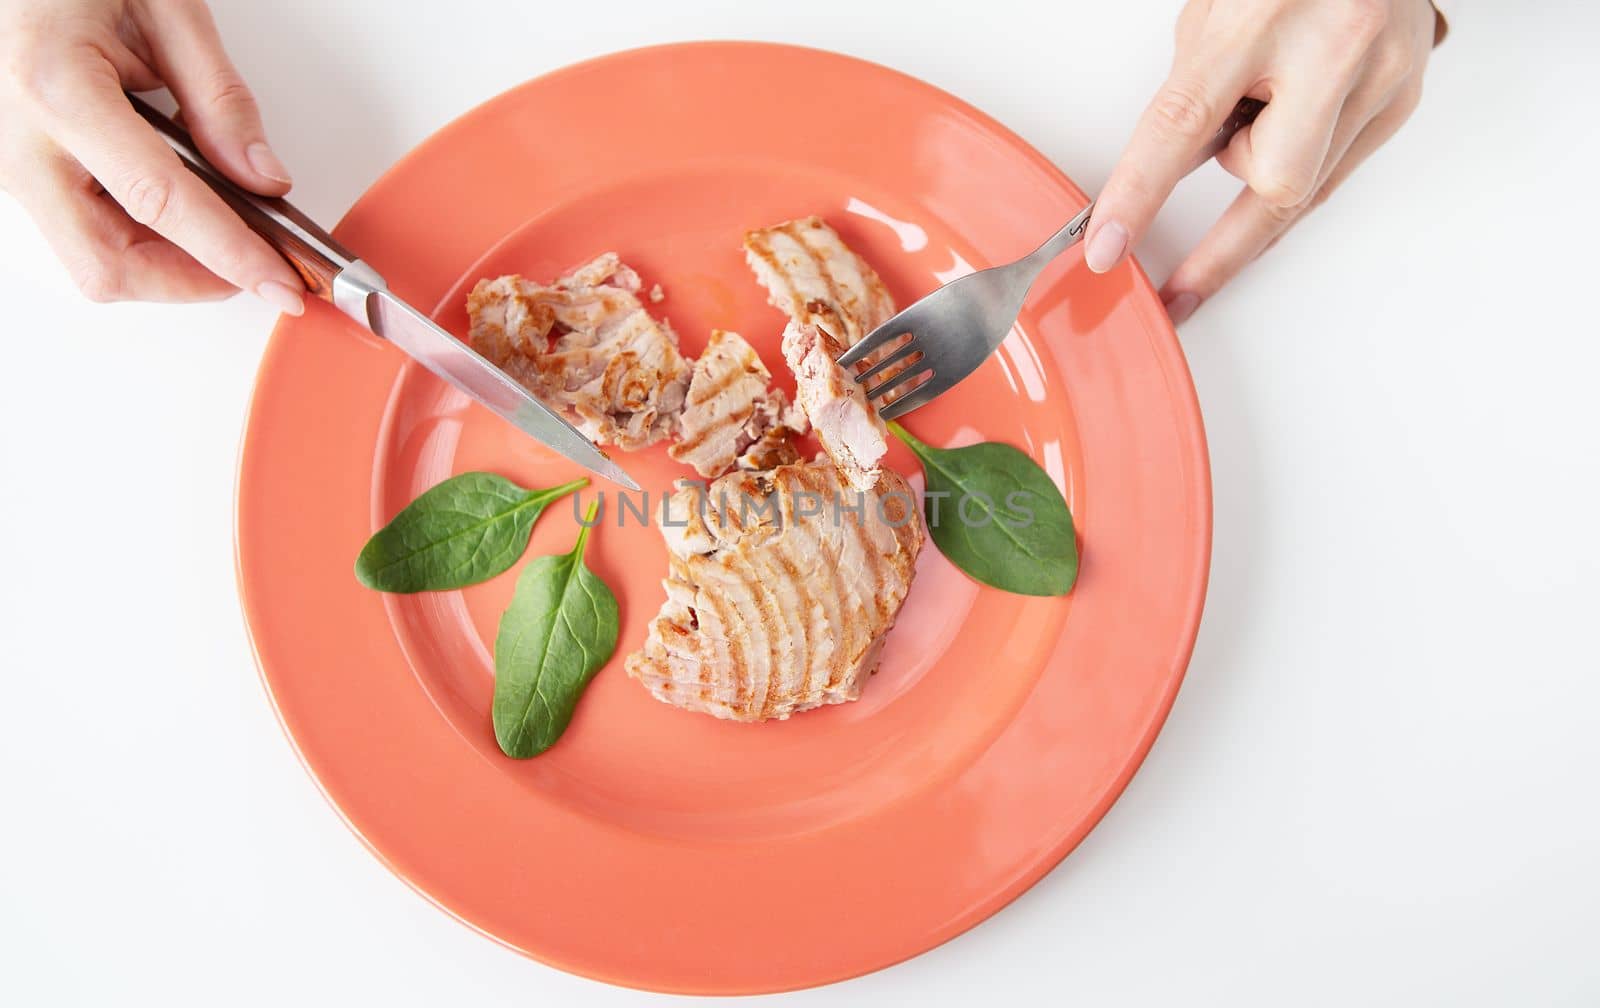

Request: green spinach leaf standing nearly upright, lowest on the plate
left=494, top=501, right=621, bottom=760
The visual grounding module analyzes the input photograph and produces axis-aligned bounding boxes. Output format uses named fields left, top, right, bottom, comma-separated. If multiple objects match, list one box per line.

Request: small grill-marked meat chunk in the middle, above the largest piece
left=667, top=330, right=806, bottom=477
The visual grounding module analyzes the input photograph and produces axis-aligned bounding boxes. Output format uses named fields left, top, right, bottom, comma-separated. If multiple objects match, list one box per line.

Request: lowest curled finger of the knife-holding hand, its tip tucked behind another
left=16, top=142, right=234, bottom=301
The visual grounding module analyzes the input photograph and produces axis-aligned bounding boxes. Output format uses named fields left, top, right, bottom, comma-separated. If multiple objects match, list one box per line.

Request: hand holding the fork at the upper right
left=1085, top=0, right=1438, bottom=323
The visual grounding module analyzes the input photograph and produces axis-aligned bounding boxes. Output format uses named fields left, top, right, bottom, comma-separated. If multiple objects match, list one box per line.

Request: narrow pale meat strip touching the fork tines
left=782, top=322, right=890, bottom=490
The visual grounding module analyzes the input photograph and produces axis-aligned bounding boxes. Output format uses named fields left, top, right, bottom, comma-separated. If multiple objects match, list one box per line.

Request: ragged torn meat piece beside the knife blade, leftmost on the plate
left=467, top=253, right=690, bottom=450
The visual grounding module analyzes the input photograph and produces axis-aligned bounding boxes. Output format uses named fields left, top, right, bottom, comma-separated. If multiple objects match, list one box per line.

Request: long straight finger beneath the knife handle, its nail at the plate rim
left=32, top=50, right=304, bottom=314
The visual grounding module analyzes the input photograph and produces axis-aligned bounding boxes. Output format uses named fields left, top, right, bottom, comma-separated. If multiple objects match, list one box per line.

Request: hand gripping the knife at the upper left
left=0, top=0, right=304, bottom=315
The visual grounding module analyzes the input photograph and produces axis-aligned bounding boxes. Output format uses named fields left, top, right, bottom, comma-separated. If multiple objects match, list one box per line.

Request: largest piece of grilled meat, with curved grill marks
left=626, top=458, right=923, bottom=722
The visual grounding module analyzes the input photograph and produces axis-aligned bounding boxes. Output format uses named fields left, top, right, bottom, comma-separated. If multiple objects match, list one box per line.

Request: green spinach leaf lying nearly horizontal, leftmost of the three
left=355, top=472, right=589, bottom=592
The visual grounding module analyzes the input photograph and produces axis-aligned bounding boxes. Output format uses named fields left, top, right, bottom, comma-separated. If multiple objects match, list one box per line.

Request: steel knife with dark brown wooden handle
left=128, top=94, right=638, bottom=490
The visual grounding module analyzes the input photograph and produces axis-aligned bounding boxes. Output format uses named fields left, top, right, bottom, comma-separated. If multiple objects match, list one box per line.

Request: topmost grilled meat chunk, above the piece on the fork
left=744, top=218, right=894, bottom=357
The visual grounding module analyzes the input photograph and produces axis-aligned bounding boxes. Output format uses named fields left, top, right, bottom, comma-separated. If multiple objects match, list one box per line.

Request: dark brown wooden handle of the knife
left=128, top=94, right=355, bottom=302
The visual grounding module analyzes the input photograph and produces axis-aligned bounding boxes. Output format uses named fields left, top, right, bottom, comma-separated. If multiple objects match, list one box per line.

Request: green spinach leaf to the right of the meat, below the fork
left=890, top=422, right=1078, bottom=595
